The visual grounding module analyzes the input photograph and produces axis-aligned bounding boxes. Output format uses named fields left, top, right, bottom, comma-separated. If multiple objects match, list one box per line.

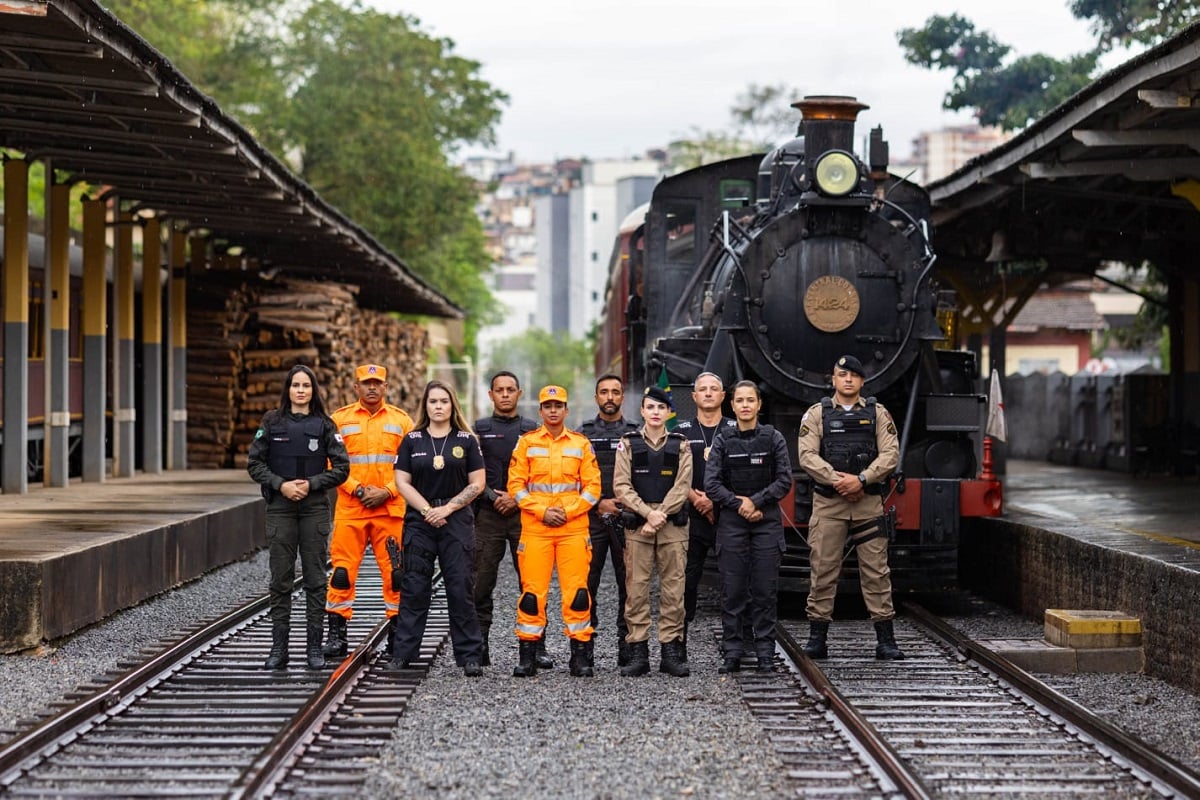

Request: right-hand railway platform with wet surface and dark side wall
left=960, top=461, right=1200, bottom=691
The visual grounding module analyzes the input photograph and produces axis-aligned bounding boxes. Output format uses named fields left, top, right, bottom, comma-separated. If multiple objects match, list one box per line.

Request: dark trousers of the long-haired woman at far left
left=266, top=492, right=334, bottom=627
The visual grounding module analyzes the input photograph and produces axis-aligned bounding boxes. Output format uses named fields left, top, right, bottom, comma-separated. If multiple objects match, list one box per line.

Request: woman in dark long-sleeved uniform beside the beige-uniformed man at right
left=704, top=380, right=792, bottom=673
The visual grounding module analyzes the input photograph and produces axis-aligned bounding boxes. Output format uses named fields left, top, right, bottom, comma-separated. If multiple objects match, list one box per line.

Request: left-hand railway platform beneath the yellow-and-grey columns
left=0, top=469, right=265, bottom=652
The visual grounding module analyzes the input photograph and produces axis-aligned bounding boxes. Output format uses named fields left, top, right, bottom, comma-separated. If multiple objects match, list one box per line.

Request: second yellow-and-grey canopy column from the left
left=42, top=177, right=71, bottom=488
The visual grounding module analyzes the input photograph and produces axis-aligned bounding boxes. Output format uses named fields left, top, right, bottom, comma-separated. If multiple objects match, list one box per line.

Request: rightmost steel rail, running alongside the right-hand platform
left=900, top=601, right=1200, bottom=798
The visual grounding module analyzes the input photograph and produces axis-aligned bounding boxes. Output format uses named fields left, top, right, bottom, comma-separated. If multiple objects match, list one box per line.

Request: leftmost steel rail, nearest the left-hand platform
left=0, top=582, right=274, bottom=786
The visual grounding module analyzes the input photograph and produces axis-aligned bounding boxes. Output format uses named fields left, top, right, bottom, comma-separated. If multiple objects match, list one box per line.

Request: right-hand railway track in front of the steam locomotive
left=738, top=606, right=1200, bottom=799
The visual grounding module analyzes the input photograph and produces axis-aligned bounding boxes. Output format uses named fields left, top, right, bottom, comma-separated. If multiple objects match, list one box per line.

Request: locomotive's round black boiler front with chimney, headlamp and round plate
left=713, top=97, right=943, bottom=402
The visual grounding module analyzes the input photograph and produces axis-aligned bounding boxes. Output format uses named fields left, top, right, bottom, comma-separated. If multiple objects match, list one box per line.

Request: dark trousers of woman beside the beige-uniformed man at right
left=716, top=509, right=785, bottom=658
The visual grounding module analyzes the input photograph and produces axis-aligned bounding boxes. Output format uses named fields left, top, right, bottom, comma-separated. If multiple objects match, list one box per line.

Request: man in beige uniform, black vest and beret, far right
left=797, top=355, right=904, bottom=660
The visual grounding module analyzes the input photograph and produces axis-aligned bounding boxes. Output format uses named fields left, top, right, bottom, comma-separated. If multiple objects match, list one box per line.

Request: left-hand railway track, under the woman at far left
left=0, top=571, right=449, bottom=798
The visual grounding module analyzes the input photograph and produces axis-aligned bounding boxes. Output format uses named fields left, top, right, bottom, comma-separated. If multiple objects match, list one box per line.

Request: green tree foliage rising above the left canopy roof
left=96, top=0, right=508, bottom=350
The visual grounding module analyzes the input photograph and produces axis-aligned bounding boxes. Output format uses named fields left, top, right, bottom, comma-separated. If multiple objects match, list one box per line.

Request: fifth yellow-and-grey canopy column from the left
left=142, top=219, right=163, bottom=474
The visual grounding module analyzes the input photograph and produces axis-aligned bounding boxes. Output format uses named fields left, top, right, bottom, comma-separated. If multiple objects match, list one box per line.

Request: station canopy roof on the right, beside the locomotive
left=928, top=25, right=1200, bottom=288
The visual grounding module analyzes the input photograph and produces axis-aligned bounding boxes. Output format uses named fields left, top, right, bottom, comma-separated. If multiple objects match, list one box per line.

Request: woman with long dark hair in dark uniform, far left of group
left=246, top=365, right=350, bottom=669
